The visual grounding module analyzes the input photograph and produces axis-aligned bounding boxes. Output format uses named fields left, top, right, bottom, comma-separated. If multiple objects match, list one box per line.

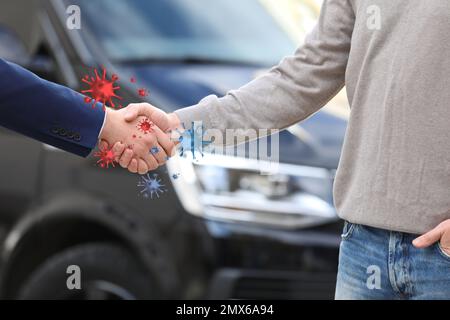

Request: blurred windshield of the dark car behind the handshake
left=71, top=0, right=300, bottom=65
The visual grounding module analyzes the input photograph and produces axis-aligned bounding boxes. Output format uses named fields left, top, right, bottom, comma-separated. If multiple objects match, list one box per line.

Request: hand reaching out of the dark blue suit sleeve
left=100, top=108, right=173, bottom=174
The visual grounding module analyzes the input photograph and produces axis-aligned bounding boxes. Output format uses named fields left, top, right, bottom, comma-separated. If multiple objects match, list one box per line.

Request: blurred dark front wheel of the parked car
left=18, top=243, right=157, bottom=300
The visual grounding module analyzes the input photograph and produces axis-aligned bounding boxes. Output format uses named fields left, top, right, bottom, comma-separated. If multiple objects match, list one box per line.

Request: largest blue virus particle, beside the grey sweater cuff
left=173, top=122, right=213, bottom=159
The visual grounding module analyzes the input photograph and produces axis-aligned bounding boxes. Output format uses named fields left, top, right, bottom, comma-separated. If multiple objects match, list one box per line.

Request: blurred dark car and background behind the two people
left=0, top=0, right=349, bottom=299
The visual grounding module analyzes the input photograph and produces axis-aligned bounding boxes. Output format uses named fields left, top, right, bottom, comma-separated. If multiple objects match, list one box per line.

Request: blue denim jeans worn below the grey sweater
left=335, top=222, right=450, bottom=300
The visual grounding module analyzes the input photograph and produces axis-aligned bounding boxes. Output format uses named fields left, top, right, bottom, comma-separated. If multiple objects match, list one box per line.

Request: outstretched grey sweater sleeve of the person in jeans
left=175, top=0, right=355, bottom=140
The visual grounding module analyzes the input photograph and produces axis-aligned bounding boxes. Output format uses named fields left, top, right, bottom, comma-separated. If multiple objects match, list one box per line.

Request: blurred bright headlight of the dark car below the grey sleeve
left=167, top=155, right=337, bottom=228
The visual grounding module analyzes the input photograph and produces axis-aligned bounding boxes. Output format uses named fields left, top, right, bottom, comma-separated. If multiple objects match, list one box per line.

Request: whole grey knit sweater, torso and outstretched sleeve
left=177, top=0, right=450, bottom=233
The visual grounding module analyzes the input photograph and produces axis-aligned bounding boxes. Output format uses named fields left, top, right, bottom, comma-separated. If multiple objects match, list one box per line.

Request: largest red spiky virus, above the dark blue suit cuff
left=81, top=68, right=122, bottom=110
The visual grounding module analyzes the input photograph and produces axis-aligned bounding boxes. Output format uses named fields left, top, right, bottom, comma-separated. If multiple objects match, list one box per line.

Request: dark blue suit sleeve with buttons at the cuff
left=0, top=59, right=105, bottom=157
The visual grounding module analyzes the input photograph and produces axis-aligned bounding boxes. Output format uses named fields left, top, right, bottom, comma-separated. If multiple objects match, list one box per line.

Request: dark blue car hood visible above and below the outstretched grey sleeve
left=117, top=63, right=347, bottom=169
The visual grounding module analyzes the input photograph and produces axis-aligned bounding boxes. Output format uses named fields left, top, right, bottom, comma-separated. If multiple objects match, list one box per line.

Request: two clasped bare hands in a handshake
left=99, top=103, right=182, bottom=174
